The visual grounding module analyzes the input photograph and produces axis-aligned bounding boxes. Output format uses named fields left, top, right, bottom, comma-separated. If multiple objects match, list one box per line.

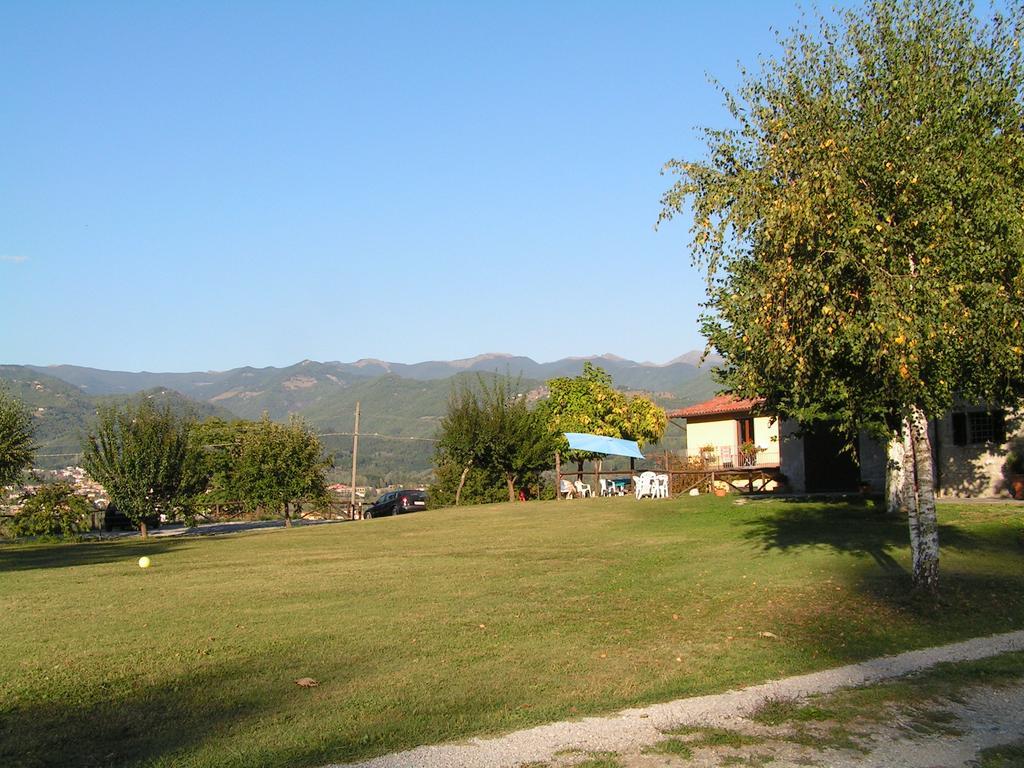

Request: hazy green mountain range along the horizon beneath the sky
left=0, top=352, right=718, bottom=485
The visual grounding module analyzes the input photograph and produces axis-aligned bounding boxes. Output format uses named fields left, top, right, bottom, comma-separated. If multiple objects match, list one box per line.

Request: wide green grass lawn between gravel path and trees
left=0, top=497, right=1024, bottom=766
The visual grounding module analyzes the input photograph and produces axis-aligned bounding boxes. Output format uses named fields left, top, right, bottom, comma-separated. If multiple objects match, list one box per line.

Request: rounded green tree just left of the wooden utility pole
left=229, top=414, right=330, bottom=527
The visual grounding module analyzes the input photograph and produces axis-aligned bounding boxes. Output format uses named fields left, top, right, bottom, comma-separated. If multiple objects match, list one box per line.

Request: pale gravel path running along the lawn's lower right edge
left=331, top=631, right=1024, bottom=768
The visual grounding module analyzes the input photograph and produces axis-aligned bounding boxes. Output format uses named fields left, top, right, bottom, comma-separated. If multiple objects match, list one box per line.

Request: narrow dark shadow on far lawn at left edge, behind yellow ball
left=0, top=539, right=195, bottom=573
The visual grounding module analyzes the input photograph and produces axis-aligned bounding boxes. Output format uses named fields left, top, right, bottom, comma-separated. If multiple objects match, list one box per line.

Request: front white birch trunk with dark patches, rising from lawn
left=907, top=406, right=939, bottom=596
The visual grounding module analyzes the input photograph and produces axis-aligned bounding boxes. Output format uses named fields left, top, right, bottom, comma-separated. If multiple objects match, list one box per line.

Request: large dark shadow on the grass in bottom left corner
left=0, top=656, right=354, bottom=768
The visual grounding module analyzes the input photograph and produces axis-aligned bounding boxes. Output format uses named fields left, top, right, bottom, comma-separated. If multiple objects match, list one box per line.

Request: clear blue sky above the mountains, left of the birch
left=0, top=0, right=811, bottom=371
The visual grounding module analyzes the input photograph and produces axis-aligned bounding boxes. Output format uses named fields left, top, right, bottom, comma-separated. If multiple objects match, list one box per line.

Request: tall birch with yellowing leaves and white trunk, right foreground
left=662, top=0, right=1024, bottom=593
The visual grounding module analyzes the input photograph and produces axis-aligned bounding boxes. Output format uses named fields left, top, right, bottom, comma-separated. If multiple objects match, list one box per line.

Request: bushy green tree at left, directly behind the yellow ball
left=82, top=397, right=193, bottom=539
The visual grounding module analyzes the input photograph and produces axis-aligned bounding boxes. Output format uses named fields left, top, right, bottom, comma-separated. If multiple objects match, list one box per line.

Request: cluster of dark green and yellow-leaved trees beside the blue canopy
left=431, top=362, right=668, bottom=505
